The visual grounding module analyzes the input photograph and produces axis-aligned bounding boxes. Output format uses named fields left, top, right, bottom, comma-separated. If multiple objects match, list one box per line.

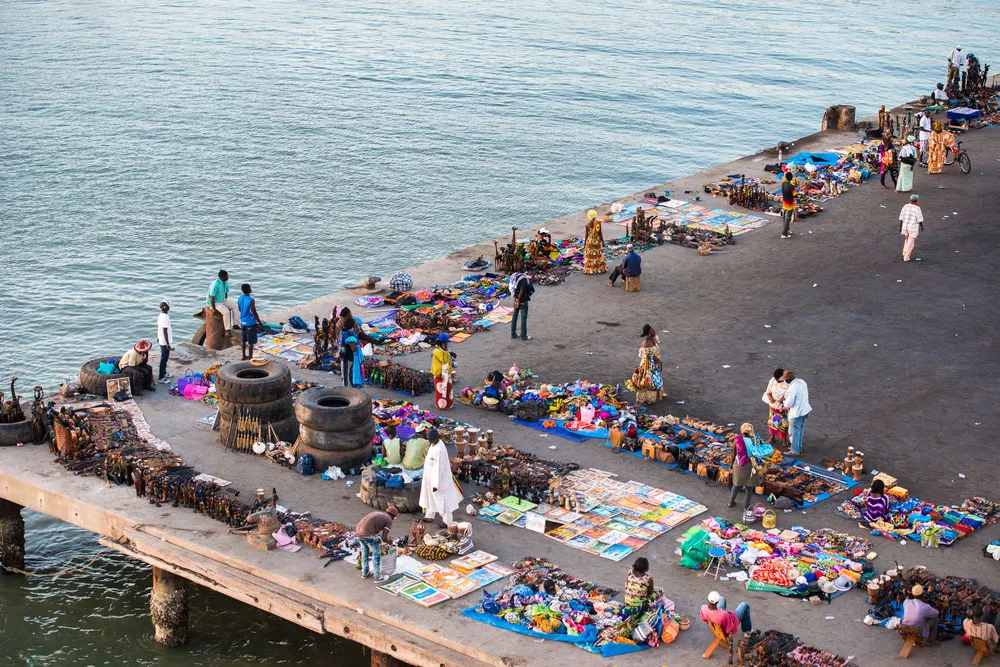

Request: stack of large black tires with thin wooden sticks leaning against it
left=215, top=361, right=299, bottom=445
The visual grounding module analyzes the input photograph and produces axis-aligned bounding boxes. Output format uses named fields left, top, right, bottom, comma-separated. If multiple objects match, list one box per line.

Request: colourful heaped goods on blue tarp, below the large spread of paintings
left=462, top=557, right=690, bottom=658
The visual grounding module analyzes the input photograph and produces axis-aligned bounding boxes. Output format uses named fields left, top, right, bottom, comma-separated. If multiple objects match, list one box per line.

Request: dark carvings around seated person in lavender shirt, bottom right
left=864, top=566, right=1000, bottom=633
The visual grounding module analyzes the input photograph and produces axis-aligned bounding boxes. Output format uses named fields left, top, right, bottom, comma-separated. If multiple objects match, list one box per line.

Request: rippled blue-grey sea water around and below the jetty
left=0, top=0, right=1000, bottom=665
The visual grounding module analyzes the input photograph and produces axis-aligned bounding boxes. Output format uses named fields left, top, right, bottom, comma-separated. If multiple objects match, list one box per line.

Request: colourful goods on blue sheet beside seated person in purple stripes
left=836, top=478, right=1000, bottom=547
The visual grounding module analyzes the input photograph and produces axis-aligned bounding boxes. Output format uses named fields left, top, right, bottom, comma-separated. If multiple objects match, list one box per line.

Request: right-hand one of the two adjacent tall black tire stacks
left=295, top=387, right=375, bottom=472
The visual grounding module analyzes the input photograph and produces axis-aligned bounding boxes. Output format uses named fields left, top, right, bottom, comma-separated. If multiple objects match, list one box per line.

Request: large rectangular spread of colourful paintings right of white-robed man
left=477, top=469, right=708, bottom=561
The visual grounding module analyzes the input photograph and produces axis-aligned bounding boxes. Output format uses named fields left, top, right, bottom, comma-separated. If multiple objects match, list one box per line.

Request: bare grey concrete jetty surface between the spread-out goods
left=0, top=112, right=1000, bottom=667
